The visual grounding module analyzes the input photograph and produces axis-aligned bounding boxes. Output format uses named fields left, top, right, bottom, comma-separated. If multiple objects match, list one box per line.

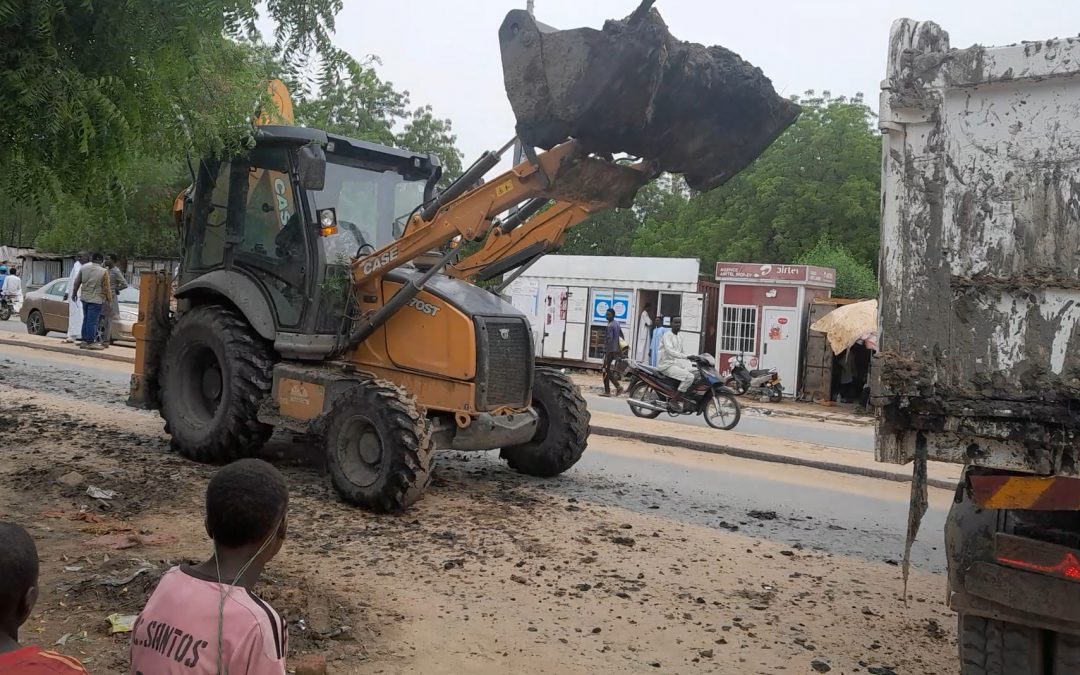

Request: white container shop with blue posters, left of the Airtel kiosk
left=503, top=255, right=702, bottom=365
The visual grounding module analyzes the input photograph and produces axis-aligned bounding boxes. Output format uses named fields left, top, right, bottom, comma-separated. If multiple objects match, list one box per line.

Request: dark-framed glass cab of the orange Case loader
left=176, top=126, right=441, bottom=359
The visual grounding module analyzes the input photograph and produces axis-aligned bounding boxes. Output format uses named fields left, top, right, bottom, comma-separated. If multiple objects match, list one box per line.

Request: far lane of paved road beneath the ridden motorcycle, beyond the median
left=585, top=394, right=874, bottom=453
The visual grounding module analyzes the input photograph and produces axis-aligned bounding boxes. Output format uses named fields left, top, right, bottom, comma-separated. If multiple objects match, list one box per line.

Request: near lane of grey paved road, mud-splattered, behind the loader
left=0, top=345, right=949, bottom=571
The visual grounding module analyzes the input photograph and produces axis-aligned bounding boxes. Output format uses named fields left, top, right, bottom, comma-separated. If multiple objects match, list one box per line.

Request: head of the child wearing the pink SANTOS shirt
left=206, top=459, right=288, bottom=561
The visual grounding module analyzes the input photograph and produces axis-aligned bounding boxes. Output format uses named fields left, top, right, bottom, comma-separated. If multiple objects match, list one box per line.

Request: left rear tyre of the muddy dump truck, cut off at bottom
left=958, top=615, right=1045, bottom=675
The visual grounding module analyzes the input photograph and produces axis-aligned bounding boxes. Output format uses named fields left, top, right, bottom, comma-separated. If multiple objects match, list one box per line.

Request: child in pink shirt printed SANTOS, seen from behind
left=131, top=459, right=288, bottom=675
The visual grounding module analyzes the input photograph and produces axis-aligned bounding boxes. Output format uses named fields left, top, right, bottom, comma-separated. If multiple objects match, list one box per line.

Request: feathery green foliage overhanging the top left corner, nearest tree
left=0, top=0, right=350, bottom=206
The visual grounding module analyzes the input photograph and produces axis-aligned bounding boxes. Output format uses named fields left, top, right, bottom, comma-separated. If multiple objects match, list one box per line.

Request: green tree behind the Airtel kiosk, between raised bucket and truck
left=633, top=92, right=881, bottom=264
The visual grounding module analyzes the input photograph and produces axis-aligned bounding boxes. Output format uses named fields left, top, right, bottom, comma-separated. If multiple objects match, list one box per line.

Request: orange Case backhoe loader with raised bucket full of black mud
left=129, top=5, right=798, bottom=511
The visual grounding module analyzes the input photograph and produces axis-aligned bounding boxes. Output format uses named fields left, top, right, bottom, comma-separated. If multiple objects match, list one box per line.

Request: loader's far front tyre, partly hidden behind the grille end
left=501, top=368, right=590, bottom=477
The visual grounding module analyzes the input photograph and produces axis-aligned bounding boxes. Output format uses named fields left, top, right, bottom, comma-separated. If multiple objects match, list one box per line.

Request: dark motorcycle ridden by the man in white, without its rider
left=626, top=354, right=742, bottom=430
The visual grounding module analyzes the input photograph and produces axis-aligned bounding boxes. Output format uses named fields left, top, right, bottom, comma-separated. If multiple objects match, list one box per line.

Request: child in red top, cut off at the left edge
left=0, top=523, right=86, bottom=675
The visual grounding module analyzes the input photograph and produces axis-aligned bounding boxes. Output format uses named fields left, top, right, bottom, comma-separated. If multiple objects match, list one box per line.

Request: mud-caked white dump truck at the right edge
left=873, top=19, right=1080, bottom=675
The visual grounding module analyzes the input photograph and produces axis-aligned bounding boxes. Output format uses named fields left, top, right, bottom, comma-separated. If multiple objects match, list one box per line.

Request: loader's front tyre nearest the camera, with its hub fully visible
left=326, top=380, right=435, bottom=512
